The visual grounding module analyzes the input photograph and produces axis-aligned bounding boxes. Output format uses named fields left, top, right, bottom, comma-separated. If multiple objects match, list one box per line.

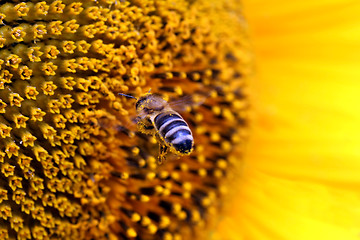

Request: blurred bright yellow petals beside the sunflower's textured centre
left=214, top=0, right=360, bottom=239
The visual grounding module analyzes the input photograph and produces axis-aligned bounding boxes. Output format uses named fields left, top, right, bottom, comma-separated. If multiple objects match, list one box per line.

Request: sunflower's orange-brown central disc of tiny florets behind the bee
left=0, top=0, right=250, bottom=240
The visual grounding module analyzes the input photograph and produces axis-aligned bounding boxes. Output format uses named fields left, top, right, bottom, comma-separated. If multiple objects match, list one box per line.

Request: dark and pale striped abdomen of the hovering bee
left=154, top=111, right=194, bottom=154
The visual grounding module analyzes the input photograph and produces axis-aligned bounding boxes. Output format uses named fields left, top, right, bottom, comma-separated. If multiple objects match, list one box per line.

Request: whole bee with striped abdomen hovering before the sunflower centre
left=119, top=93, right=194, bottom=163
